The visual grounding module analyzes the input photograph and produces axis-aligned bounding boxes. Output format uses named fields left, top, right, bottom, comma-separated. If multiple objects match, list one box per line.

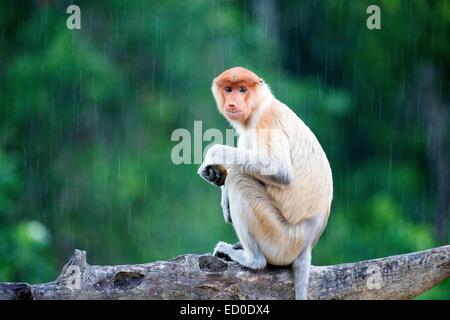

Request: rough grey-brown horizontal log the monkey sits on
left=0, top=245, right=450, bottom=300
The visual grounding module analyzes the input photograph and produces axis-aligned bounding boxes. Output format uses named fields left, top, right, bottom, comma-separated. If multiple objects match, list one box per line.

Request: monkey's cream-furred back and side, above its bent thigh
left=267, top=101, right=333, bottom=229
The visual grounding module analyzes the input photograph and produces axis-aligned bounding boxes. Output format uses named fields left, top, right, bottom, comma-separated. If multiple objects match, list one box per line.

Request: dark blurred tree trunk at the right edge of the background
left=417, top=64, right=450, bottom=243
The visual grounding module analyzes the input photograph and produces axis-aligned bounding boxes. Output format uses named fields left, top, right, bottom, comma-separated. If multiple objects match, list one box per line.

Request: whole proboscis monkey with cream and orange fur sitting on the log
left=198, top=67, right=333, bottom=299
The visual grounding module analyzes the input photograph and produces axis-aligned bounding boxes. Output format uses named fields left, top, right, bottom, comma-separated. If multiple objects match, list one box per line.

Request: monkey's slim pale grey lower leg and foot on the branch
left=214, top=173, right=266, bottom=269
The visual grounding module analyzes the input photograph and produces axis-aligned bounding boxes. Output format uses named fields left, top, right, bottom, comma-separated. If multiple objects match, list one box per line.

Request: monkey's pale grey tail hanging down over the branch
left=292, top=246, right=311, bottom=300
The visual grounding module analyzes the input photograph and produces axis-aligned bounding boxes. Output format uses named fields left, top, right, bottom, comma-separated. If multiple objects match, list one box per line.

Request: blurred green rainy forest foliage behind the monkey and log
left=0, top=0, right=450, bottom=299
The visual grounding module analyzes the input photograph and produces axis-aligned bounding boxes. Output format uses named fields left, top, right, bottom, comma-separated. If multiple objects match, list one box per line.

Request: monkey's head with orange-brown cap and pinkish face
left=212, top=67, right=268, bottom=124
